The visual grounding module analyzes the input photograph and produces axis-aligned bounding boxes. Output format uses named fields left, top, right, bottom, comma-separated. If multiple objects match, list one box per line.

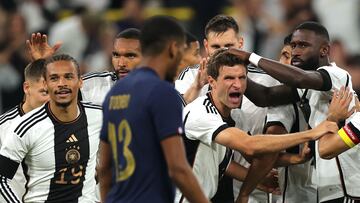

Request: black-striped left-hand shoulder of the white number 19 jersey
left=13, top=104, right=49, bottom=137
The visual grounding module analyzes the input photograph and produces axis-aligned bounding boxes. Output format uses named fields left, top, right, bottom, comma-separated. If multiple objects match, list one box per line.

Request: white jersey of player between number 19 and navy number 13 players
left=80, top=72, right=118, bottom=105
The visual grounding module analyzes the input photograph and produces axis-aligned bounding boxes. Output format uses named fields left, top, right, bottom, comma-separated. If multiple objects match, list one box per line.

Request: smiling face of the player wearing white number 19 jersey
left=46, top=61, right=82, bottom=108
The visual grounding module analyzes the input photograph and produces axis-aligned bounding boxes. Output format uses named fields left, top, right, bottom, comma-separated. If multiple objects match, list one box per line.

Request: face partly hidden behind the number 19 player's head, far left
left=25, top=77, right=49, bottom=109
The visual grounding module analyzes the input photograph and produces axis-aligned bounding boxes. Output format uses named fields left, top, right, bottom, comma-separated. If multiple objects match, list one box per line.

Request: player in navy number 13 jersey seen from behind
left=99, top=16, right=208, bottom=203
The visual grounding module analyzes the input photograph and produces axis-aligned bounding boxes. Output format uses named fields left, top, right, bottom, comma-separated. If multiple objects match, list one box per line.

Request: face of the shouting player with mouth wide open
left=209, top=65, right=247, bottom=116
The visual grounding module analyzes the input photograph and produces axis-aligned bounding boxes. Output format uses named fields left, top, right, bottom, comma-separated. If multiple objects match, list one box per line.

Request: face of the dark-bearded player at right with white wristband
left=290, top=30, right=323, bottom=70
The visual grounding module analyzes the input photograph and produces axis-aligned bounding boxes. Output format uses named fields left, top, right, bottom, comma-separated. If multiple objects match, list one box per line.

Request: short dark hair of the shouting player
left=207, top=49, right=247, bottom=80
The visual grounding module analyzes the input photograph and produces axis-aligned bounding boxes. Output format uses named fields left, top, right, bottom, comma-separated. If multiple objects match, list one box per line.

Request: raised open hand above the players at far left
left=26, top=33, right=61, bottom=60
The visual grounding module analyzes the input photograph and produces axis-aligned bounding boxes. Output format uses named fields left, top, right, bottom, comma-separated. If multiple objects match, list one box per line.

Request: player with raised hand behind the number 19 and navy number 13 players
left=26, top=28, right=141, bottom=105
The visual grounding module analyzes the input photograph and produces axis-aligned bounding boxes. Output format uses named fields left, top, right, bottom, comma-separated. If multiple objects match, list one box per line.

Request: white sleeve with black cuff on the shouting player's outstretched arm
left=184, top=106, right=229, bottom=146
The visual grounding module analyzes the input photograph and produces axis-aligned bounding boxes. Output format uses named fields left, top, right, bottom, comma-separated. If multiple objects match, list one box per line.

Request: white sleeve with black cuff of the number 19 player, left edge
left=0, top=125, right=30, bottom=179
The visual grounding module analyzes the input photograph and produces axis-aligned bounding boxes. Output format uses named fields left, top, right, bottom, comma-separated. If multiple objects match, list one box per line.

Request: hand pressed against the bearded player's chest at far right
left=328, top=87, right=356, bottom=122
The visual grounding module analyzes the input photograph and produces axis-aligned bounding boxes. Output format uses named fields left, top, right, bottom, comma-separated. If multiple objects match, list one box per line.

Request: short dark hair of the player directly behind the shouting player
left=205, top=15, right=239, bottom=38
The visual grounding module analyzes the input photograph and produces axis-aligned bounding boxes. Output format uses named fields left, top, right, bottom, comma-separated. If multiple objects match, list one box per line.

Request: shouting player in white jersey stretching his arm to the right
left=177, top=50, right=337, bottom=202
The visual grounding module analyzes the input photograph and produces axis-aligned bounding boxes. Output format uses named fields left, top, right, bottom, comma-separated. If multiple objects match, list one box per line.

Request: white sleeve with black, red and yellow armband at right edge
left=338, top=112, right=360, bottom=148
